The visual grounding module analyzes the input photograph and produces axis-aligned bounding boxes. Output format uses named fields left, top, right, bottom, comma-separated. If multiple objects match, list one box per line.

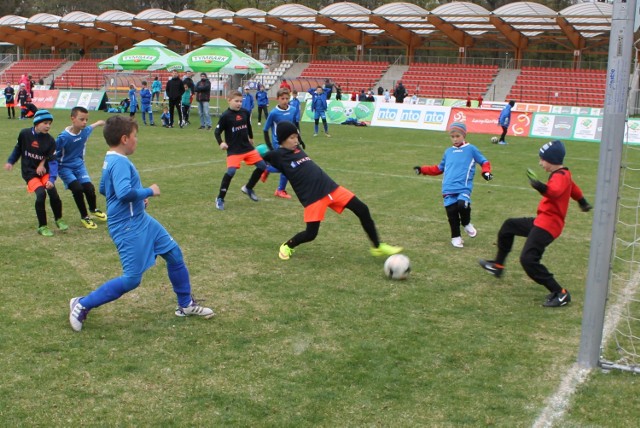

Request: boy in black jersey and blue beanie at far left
left=4, top=110, right=69, bottom=237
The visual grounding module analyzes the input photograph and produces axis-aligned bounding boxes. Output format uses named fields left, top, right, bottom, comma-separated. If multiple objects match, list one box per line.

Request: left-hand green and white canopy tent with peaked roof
left=98, top=39, right=185, bottom=71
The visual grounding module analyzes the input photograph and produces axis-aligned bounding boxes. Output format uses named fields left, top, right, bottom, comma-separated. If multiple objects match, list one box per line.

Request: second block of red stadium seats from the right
left=402, top=63, right=498, bottom=99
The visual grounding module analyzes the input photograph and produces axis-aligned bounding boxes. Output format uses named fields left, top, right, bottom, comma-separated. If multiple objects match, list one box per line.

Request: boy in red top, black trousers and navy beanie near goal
left=479, top=140, right=591, bottom=307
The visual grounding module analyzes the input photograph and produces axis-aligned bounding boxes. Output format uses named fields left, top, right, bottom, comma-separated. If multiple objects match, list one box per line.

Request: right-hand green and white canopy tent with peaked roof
left=182, top=39, right=266, bottom=74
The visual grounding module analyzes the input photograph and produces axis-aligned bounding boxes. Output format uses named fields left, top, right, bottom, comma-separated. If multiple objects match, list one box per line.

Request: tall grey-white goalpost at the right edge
left=578, top=0, right=636, bottom=369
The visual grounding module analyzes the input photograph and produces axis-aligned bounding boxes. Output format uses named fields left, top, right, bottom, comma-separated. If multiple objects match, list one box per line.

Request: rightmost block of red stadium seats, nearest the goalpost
left=507, top=67, right=606, bottom=107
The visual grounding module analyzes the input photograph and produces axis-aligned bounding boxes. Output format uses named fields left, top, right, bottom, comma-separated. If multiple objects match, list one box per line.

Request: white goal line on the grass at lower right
left=532, top=272, right=640, bottom=428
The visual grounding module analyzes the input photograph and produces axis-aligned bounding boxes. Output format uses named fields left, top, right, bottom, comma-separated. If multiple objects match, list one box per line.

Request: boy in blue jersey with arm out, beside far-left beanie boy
left=56, top=106, right=107, bottom=229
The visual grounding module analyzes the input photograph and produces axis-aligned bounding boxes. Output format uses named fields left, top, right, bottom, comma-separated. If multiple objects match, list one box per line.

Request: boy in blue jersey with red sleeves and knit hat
left=413, top=122, right=493, bottom=248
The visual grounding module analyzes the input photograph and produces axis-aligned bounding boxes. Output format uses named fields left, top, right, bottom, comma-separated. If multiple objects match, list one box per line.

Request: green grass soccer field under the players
left=0, top=110, right=640, bottom=427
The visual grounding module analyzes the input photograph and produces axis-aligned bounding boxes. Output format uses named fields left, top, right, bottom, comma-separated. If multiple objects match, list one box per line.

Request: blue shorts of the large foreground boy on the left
left=111, top=214, right=178, bottom=276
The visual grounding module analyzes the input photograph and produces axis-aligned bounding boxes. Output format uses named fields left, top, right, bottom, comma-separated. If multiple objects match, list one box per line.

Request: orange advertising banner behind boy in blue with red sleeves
left=447, top=107, right=531, bottom=137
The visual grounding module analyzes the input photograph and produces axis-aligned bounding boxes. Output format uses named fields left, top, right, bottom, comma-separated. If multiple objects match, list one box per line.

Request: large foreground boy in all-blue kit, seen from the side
left=69, top=116, right=214, bottom=331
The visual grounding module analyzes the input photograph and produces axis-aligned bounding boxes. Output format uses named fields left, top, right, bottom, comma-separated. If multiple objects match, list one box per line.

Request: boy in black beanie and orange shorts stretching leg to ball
left=264, top=121, right=402, bottom=260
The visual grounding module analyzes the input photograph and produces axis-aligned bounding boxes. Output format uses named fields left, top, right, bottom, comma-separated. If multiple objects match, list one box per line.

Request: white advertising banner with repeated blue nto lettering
left=371, top=104, right=451, bottom=131
